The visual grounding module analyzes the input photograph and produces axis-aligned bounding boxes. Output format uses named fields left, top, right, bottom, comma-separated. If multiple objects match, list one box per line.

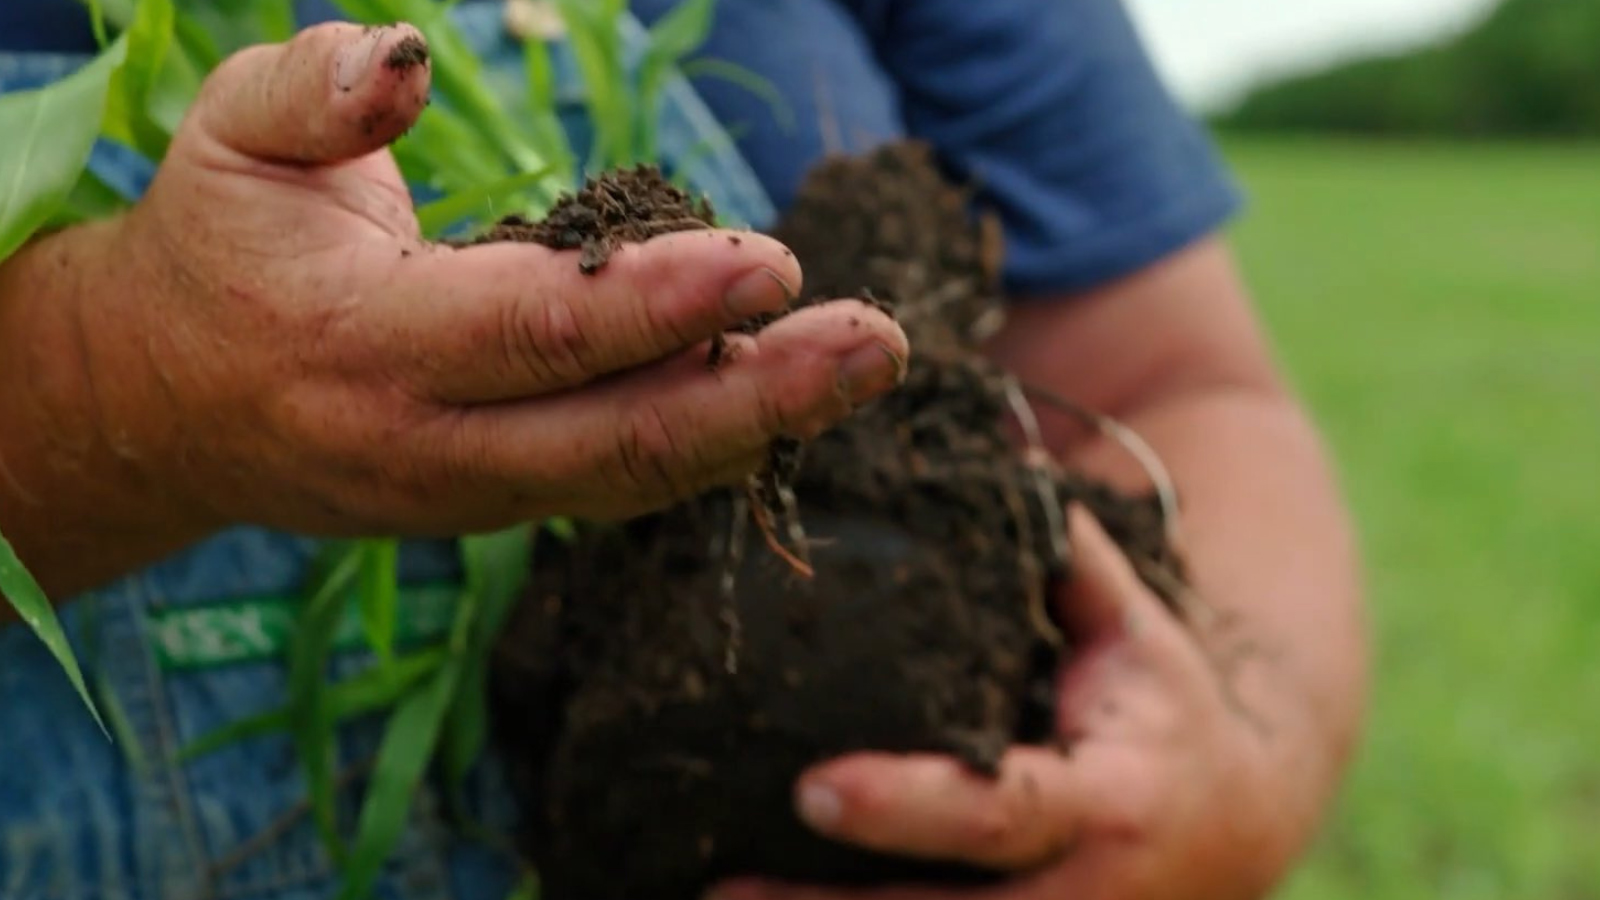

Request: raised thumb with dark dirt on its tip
left=195, top=22, right=430, bottom=165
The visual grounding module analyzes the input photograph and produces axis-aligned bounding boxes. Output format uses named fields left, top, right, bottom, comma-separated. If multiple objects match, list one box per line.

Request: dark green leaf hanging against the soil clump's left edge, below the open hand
left=440, top=525, right=538, bottom=790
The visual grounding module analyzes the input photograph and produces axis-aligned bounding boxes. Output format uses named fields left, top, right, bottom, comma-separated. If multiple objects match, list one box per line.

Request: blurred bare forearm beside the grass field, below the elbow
left=1069, top=381, right=1366, bottom=838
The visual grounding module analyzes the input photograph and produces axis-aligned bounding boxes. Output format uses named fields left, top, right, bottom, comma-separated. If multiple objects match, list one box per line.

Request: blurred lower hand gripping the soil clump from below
left=714, top=509, right=1307, bottom=900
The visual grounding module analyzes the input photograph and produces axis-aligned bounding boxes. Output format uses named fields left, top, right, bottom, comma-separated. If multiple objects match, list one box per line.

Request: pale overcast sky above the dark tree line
left=1126, top=0, right=1493, bottom=106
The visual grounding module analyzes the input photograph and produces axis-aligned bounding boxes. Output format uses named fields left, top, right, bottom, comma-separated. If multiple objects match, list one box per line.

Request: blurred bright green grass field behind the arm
left=1224, top=139, right=1600, bottom=900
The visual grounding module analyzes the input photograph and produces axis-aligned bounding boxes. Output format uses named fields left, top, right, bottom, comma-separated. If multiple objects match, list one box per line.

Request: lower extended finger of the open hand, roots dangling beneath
left=454, top=301, right=909, bottom=517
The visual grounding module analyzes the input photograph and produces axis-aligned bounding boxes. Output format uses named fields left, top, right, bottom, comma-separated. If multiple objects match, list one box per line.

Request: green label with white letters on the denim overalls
left=147, top=585, right=461, bottom=669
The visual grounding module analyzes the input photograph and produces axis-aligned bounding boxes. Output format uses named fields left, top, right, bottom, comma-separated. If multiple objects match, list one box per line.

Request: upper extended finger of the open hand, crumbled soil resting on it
left=395, top=231, right=800, bottom=404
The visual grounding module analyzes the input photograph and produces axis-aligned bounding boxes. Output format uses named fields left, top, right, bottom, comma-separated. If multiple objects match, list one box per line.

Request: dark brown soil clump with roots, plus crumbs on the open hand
left=473, top=144, right=1181, bottom=900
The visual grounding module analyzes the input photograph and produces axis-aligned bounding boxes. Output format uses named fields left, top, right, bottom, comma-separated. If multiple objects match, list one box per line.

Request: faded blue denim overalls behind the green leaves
left=0, top=3, right=773, bottom=900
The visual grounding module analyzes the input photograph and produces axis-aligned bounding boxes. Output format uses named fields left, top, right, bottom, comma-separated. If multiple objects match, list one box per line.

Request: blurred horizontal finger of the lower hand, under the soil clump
left=795, top=748, right=1088, bottom=871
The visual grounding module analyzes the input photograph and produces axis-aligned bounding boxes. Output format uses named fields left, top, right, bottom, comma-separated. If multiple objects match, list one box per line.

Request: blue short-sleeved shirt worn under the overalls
left=0, top=0, right=1238, bottom=296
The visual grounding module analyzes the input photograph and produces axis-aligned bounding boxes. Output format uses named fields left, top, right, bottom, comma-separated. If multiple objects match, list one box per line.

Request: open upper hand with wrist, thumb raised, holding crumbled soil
left=0, top=24, right=909, bottom=589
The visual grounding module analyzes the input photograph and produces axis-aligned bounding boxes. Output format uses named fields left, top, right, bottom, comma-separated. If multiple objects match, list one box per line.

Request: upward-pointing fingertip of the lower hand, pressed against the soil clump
left=1058, top=503, right=1154, bottom=644
